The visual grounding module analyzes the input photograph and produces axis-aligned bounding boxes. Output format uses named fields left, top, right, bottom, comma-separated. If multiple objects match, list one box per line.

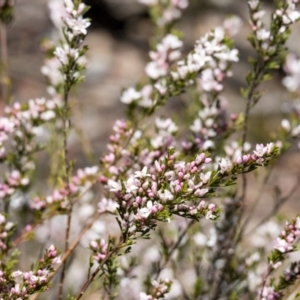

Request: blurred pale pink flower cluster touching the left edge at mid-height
left=0, top=98, right=56, bottom=198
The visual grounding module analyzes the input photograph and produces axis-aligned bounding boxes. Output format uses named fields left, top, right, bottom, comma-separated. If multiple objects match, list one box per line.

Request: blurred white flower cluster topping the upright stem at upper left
left=41, top=0, right=91, bottom=100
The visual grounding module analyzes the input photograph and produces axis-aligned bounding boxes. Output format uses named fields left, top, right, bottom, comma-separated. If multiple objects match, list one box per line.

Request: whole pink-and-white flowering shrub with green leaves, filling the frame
left=0, top=0, right=300, bottom=300
